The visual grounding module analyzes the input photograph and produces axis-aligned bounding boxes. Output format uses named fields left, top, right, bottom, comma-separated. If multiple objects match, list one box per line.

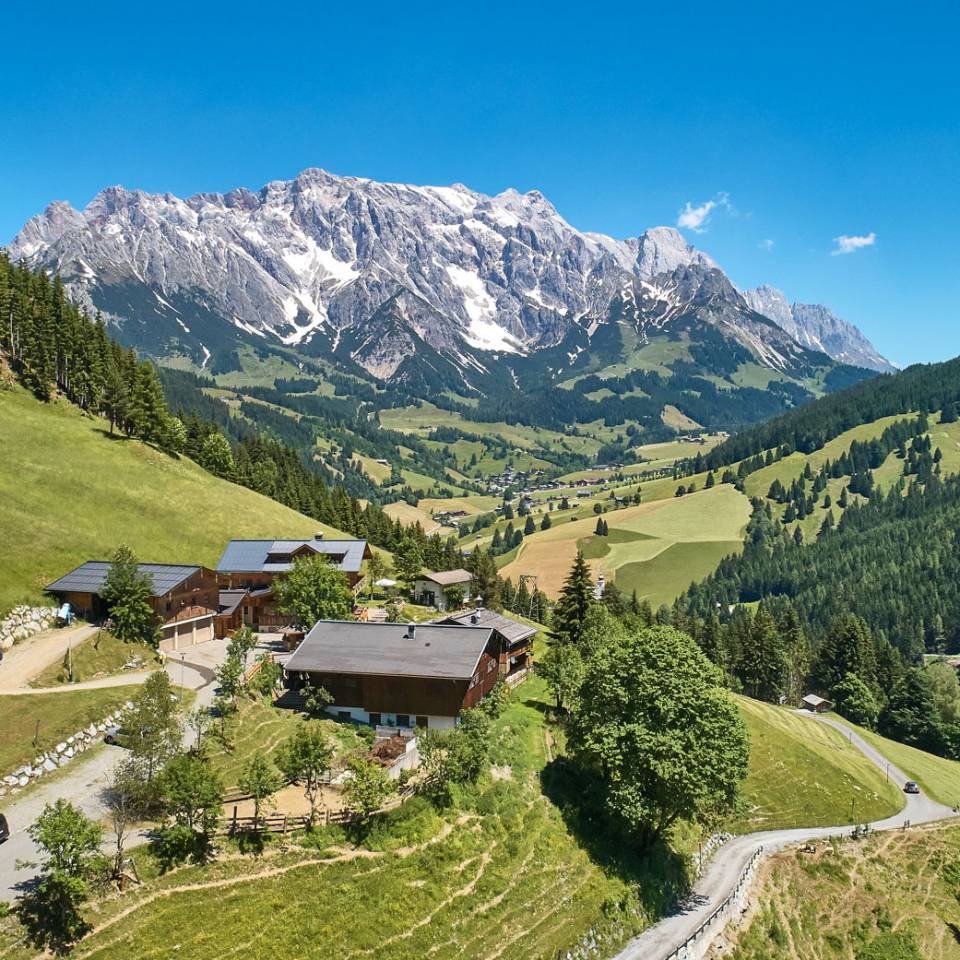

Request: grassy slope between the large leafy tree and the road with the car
left=734, top=697, right=903, bottom=833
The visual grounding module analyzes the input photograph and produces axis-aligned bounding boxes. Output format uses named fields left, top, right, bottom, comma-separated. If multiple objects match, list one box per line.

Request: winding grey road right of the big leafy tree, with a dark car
left=616, top=716, right=956, bottom=960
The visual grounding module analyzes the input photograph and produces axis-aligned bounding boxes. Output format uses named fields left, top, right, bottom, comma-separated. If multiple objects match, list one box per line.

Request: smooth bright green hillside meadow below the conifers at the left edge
left=0, top=390, right=344, bottom=611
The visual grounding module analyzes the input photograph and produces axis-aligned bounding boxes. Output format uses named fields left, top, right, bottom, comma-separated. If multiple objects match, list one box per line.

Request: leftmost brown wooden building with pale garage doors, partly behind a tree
left=46, top=560, right=220, bottom=650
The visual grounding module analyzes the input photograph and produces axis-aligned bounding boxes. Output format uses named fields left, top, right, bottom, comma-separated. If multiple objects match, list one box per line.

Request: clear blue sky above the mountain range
left=0, top=0, right=960, bottom=364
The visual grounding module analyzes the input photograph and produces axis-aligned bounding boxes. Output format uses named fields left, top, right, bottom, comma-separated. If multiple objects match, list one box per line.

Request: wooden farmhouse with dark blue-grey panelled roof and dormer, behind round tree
left=217, top=533, right=373, bottom=630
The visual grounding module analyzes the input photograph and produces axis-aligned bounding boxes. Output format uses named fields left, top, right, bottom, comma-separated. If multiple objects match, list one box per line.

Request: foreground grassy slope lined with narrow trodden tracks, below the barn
left=20, top=678, right=680, bottom=960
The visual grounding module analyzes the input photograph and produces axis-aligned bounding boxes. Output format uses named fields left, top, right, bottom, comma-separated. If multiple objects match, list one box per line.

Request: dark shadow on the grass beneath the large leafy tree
left=540, top=757, right=690, bottom=916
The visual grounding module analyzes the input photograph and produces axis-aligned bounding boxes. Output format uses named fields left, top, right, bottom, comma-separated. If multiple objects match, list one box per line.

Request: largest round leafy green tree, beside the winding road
left=570, top=627, right=750, bottom=847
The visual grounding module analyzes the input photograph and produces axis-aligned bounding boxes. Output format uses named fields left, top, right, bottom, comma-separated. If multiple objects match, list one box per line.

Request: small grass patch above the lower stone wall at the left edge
left=0, top=687, right=137, bottom=775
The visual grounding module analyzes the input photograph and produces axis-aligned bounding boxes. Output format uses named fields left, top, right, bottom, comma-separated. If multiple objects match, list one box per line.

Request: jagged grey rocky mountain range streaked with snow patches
left=9, top=169, right=890, bottom=393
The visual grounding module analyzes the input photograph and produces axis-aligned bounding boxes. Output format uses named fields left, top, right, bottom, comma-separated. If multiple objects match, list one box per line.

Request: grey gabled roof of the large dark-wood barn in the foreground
left=286, top=620, right=492, bottom=680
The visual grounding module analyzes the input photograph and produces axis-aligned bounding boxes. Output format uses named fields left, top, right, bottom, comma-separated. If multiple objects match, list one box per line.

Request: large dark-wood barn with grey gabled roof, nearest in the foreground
left=284, top=620, right=500, bottom=728
